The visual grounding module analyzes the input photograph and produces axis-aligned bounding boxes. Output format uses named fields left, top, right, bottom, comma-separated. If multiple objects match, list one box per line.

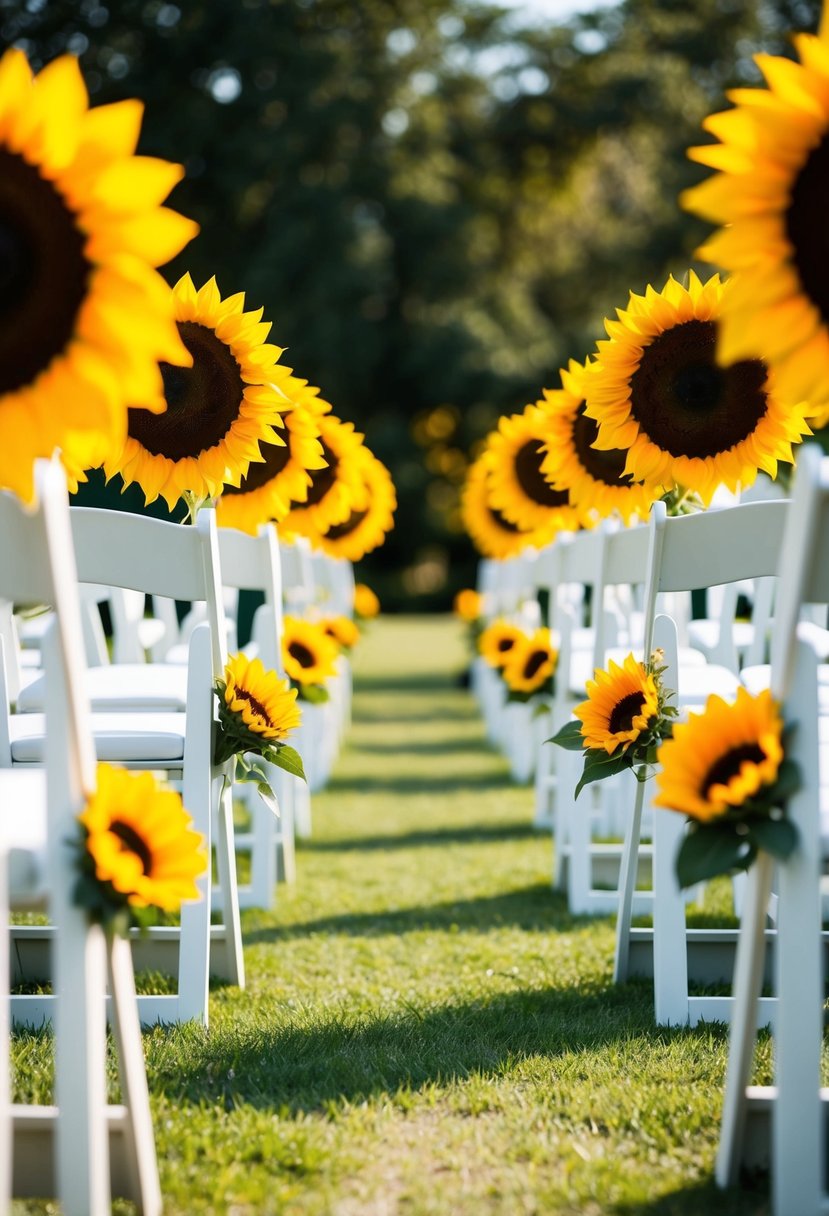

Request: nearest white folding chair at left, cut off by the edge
left=0, top=462, right=162, bottom=1216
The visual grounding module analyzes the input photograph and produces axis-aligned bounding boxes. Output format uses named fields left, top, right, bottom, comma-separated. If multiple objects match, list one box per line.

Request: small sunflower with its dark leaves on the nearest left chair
left=73, top=764, right=207, bottom=934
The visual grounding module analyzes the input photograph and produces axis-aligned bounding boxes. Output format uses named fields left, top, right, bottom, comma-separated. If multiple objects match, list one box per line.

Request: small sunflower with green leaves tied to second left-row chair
left=213, top=652, right=305, bottom=787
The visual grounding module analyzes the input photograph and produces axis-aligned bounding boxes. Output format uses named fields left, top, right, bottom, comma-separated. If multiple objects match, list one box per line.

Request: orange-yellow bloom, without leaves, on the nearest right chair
left=654, top=688, right=783, bottom=823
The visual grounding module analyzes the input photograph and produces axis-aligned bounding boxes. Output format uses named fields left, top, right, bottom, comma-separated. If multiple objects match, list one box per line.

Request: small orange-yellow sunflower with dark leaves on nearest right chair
left=654, top=688, right=800, bottom=886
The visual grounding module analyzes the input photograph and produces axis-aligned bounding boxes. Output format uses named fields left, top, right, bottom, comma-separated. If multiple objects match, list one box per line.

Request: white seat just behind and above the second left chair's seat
left=17, top=663, right=187, bottom=714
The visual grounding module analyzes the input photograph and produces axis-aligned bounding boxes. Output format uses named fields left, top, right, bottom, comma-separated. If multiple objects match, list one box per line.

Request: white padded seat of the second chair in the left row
left=10, top=714, right=186, bottom=765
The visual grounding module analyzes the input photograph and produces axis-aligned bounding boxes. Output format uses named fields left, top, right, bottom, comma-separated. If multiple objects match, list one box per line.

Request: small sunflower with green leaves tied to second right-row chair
left=547, top=651, right=677, bottom=796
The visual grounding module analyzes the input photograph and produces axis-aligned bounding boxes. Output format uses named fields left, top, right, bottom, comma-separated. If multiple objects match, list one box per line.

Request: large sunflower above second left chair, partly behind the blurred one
left=105, top=275, right=289, bottom=510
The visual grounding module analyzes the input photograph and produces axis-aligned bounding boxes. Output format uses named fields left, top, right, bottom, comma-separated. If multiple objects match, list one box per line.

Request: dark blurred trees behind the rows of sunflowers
left=6, top=0, right=818, bottom=610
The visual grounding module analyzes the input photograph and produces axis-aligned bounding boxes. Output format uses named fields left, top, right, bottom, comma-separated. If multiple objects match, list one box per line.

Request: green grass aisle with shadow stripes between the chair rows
left=13, top=618, right=769, bottom=1216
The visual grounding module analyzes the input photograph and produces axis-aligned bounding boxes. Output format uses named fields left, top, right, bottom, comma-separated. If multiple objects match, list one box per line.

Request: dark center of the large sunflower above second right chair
left=631, top=321, right=768, bottom=457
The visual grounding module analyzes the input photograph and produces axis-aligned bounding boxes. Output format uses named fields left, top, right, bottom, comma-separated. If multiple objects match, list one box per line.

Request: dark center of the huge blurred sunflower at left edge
left=0, top=148, right=91, bottom=393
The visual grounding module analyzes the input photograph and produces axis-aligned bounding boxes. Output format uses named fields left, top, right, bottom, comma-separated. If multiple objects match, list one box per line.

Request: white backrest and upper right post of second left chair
left=69, top=507, right=227, bottom=676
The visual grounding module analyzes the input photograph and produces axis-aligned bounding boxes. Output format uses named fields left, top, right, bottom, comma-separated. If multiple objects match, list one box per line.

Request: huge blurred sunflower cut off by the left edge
left=0, top=50, right=198, bottom=500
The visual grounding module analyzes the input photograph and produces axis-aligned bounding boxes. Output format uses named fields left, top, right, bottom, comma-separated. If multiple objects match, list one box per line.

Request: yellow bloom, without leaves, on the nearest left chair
left=78, top=764, right=207, bottom=912
